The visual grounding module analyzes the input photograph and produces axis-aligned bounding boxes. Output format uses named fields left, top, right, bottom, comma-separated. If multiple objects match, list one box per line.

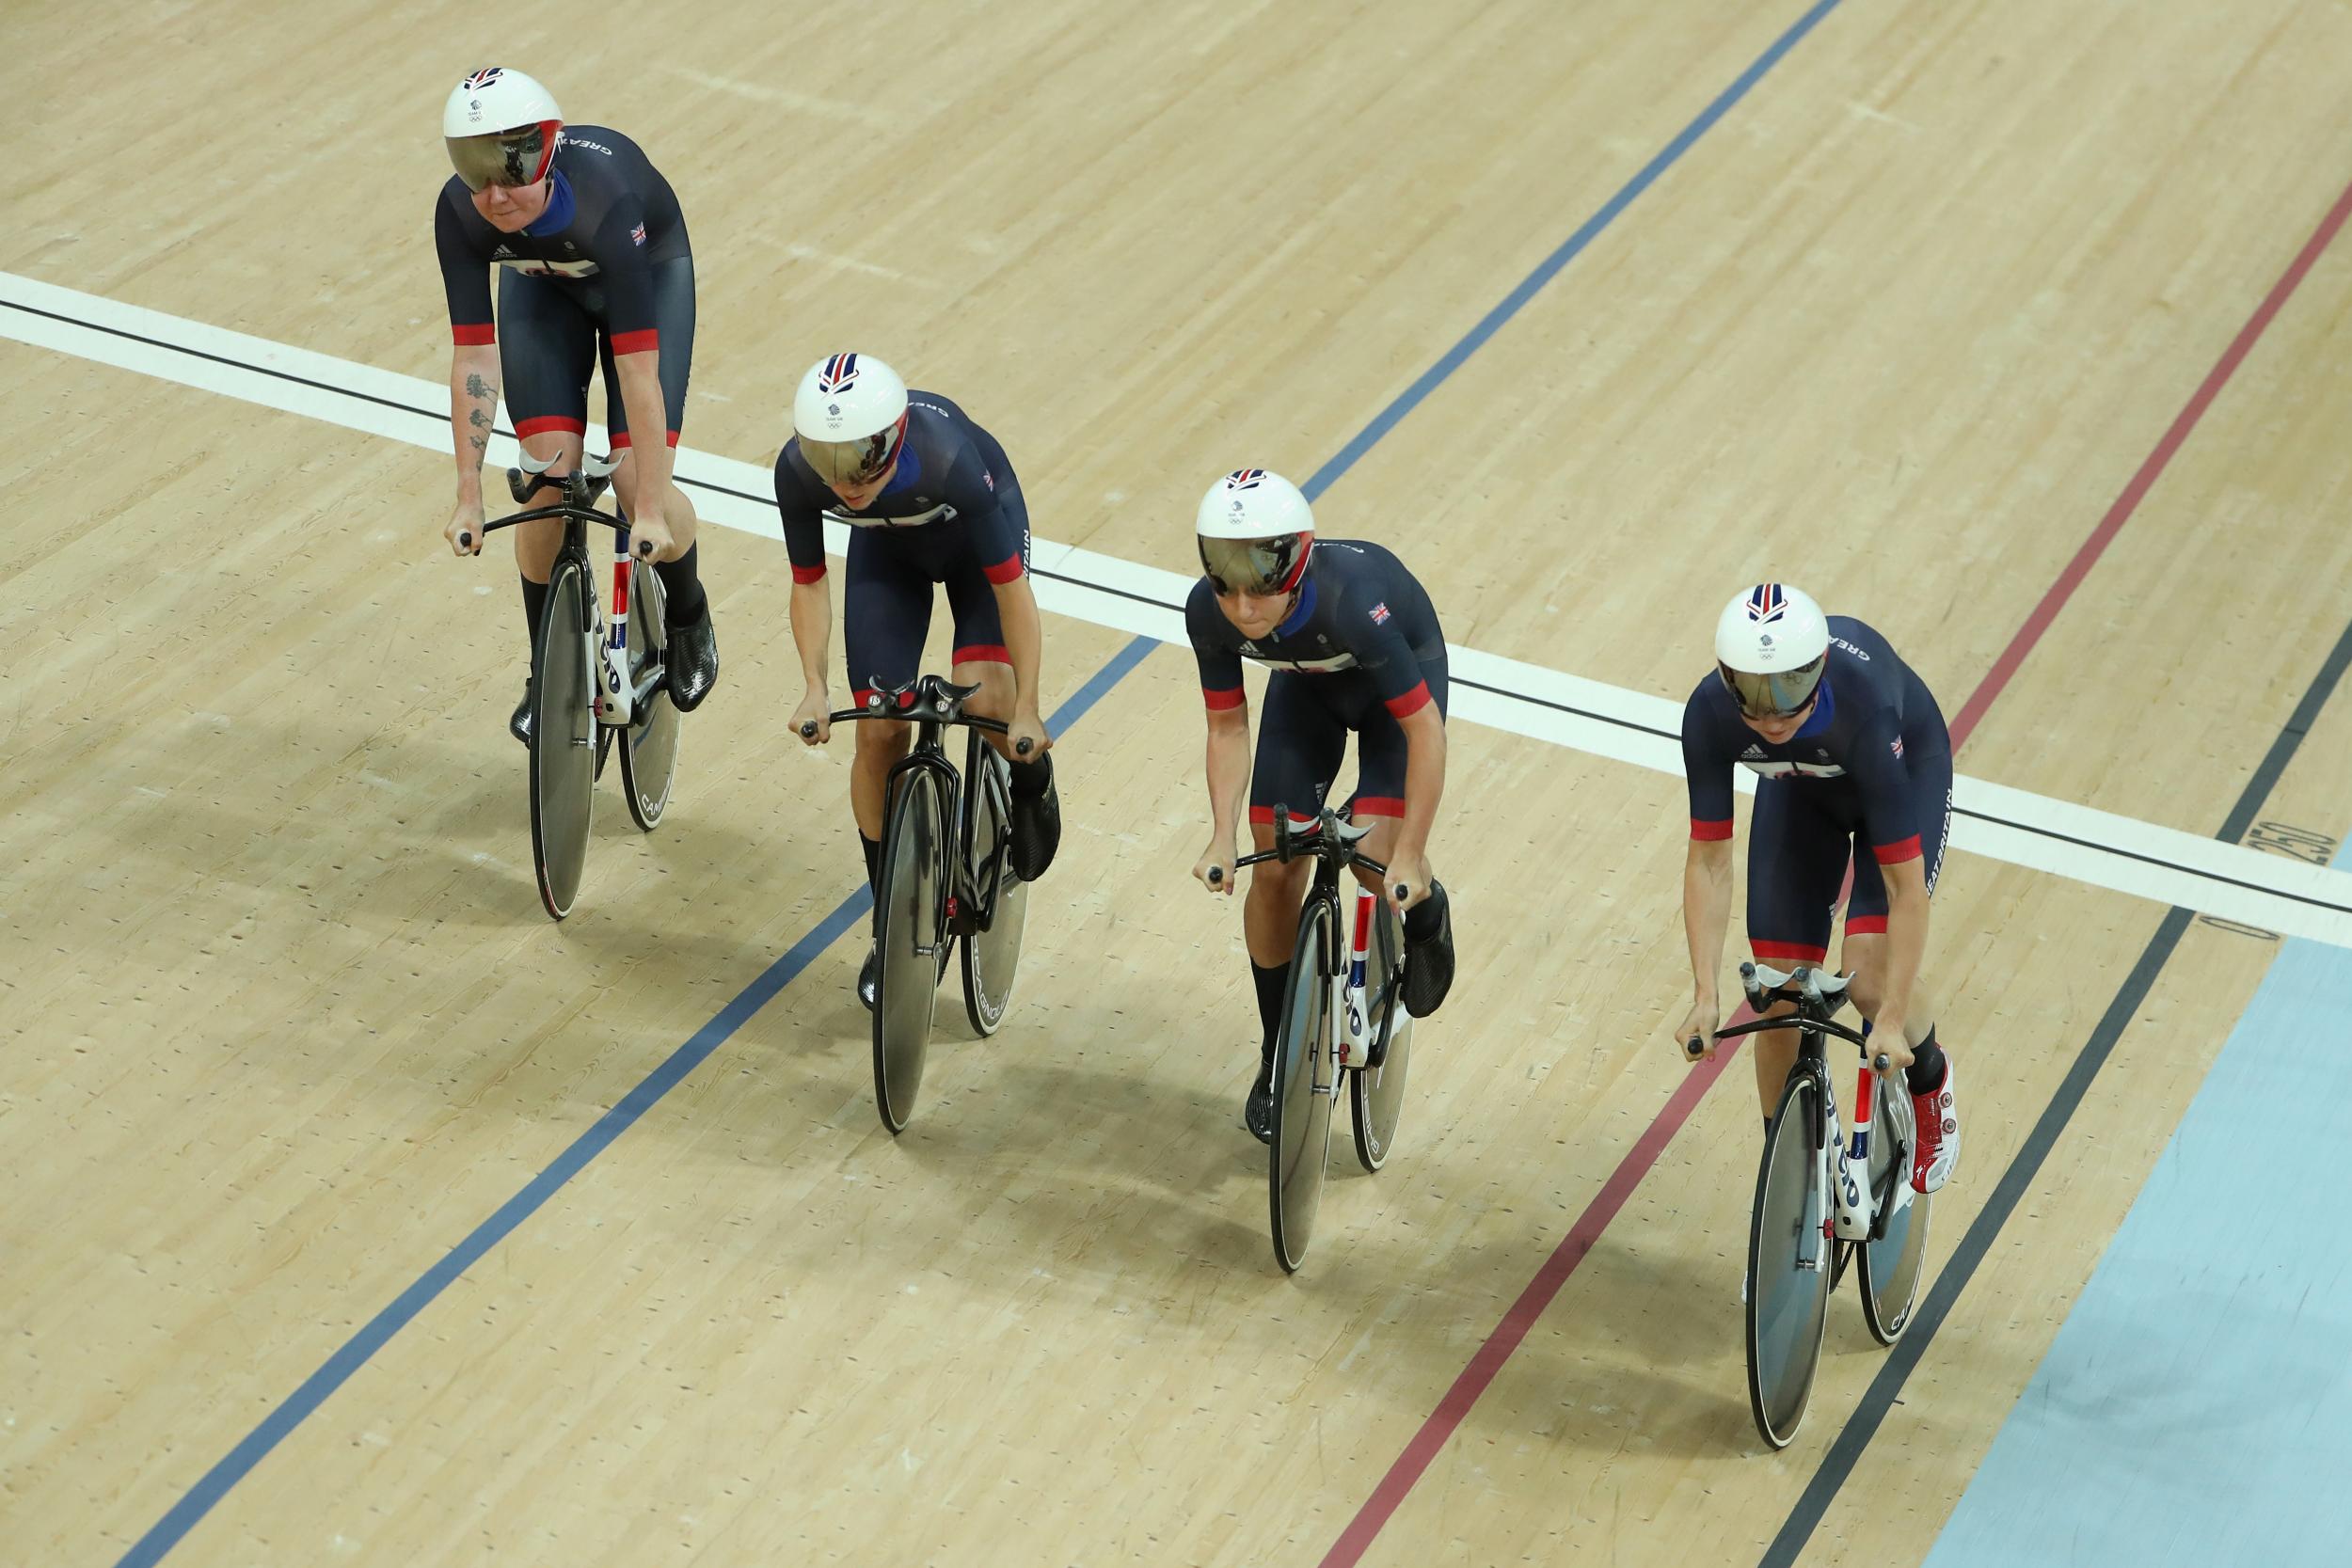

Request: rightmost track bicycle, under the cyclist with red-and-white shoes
left=1687, top=964, right=1931, bottom=1449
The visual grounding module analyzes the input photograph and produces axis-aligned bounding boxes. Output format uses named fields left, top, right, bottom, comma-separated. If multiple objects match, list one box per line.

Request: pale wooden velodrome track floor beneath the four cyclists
left=13, top=0, right=2352, bottom=1566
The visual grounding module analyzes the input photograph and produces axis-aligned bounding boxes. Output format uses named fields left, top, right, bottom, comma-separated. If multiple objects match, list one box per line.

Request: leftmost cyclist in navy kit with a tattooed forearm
left=433, top=66, right=720, bottom=743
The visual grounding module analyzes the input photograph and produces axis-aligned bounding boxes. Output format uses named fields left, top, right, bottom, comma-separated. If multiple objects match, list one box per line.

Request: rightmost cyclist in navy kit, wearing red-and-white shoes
left=1675, top=583, right=1960, bottom=1192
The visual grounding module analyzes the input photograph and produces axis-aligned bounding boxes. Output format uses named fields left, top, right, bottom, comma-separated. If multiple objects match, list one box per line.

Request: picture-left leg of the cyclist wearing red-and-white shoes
left=1748, top=778, right=1849, bottom=1119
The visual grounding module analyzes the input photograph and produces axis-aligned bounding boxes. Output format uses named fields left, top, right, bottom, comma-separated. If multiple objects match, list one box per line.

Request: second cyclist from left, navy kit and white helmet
left=776, top=355, right=1061, bottom=1006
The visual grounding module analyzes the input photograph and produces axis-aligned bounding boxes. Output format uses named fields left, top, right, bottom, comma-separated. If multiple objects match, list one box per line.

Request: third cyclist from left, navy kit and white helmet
left=1185, top=467, right=1454, bottom=1143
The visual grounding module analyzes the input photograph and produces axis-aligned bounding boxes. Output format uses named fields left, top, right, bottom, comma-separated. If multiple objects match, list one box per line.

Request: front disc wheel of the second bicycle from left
left=875, top=768, right=948, bottom=1133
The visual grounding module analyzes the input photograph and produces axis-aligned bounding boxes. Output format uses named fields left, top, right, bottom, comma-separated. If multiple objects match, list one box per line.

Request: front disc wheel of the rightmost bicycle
left=1748, top=1072, right=1833, bottom=1449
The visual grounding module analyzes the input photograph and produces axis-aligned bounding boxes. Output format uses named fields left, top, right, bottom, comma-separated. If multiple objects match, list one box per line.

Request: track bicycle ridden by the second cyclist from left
left=800, top=674, right=1030, bottom=1133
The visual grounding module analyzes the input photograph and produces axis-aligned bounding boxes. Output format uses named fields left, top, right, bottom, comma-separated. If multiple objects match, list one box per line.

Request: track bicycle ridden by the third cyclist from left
left=1209, top=806, right=1414, bottom=1275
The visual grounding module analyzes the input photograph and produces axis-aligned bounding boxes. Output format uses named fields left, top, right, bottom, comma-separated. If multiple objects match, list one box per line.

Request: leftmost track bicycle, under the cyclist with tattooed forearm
left=483, top=453, right=680, bottom=919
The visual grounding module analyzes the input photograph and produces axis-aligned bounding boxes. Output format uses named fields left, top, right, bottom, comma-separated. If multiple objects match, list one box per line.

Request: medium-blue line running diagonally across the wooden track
left=116, top=0, right=1839, bottom=1568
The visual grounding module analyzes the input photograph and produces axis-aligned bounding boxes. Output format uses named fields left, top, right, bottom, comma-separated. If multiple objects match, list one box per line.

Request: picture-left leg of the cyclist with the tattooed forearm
left=499, top=268, right=596, bottom=740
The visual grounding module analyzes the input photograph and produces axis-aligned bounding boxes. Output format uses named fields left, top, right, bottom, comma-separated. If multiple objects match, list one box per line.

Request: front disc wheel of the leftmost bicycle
left=532, top=560, right=597, bottom=919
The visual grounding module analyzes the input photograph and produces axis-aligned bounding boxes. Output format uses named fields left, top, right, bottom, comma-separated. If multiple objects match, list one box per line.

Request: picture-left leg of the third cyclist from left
left=1242, top=670, right=1348, bottom=1140
